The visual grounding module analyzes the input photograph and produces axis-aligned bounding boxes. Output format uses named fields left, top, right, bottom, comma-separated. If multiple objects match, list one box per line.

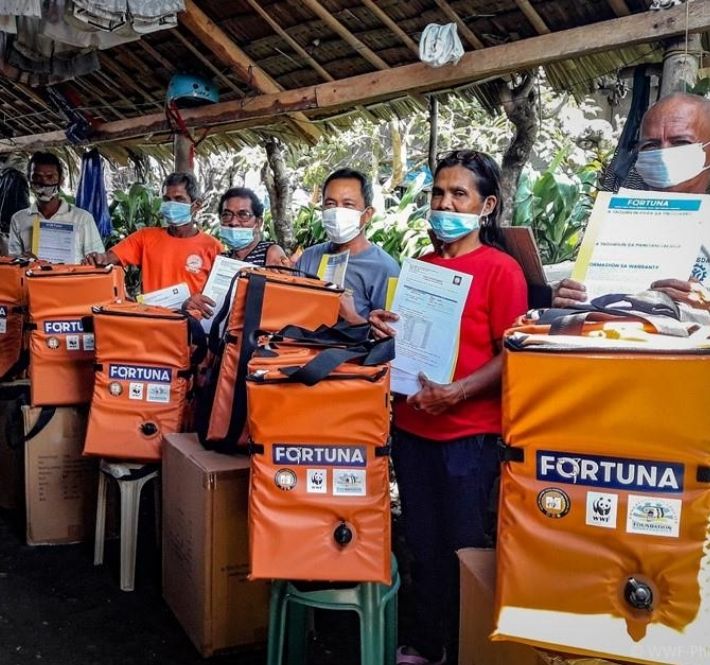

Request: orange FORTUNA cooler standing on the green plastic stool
left=247, top=340, right=393, bottom=583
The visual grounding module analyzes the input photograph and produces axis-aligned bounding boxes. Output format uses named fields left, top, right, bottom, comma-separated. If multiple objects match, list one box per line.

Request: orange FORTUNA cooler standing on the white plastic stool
left=84, top=303, right=199, bottom=461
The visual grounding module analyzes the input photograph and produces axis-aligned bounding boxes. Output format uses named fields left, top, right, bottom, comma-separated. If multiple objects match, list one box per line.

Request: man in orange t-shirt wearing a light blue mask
left=86, top=173, right=223, bottom=295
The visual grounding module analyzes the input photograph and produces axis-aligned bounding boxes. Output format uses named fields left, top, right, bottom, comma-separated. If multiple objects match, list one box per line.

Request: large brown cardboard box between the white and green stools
left=162, top=434, right=269, bottom=656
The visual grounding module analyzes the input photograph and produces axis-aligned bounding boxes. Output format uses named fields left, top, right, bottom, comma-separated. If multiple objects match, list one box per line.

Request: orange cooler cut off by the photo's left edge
left=0, top=256, right=29, bottom=381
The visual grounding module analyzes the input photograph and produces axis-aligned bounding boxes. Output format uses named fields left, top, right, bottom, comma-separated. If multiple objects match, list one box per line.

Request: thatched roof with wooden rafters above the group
left=0, top=0, right=710, bottom=158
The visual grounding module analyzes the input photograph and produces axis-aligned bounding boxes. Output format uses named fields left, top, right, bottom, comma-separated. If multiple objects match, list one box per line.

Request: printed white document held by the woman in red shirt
left=391, top=259, right=473, bottom=395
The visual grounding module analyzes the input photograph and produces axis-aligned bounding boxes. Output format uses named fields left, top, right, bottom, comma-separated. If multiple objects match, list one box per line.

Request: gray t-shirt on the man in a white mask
left=296, top=242, right=399, bottom=318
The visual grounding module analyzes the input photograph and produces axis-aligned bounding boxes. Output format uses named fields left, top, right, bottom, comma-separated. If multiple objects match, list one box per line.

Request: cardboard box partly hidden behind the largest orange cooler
left=458, top=548, right=543, bottom=665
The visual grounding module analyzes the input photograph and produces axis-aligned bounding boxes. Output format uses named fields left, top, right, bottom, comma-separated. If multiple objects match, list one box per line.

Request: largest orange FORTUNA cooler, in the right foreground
left=493, top=334, right=710, bottom=665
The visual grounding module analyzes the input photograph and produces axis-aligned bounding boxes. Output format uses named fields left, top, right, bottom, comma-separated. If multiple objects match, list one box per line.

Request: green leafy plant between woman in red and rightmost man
left=513, top=150, right=598, bottom=264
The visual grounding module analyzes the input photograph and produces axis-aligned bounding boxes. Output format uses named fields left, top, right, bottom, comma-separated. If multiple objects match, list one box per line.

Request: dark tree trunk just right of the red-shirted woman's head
left=499, top=72, right=540, bottom=226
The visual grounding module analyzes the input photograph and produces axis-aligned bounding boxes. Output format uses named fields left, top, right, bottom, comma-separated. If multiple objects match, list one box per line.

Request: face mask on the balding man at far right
left=636, top=143, right=710, bottom=189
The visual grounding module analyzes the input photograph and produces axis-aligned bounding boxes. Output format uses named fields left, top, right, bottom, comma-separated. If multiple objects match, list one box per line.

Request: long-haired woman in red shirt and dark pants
left=370, top=150, right=527, bottom=665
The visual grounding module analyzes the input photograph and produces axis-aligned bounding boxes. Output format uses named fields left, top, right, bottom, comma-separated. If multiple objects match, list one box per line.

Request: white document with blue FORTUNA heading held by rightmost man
left=572, top=190, right=710, bottom=298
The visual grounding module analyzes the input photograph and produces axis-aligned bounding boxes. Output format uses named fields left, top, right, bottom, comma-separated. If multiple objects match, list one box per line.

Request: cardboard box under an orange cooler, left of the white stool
left=22, top=406, right=99, bottom=545
